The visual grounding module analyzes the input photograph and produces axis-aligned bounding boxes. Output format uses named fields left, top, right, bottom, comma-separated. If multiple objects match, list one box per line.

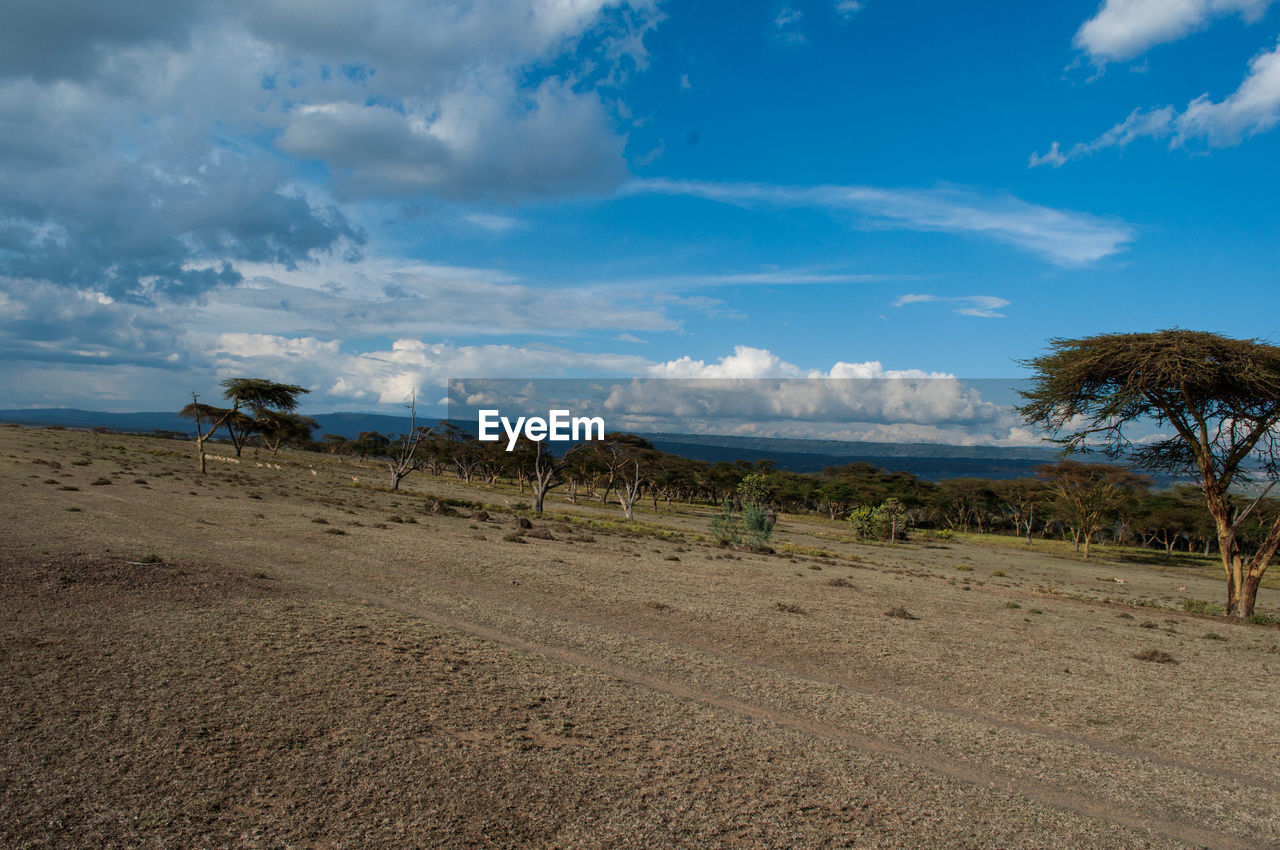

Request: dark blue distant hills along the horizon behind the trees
left=0, top=408, right=1057, bottom=481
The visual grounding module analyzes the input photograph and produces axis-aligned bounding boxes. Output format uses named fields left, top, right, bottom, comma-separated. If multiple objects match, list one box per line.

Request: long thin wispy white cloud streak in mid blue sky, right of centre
left=623, top=179, right=1134, bottom=266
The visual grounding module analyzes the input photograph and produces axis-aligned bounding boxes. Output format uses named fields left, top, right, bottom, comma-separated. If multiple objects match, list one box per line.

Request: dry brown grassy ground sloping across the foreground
left=0, top=428, right=1280, bottom=847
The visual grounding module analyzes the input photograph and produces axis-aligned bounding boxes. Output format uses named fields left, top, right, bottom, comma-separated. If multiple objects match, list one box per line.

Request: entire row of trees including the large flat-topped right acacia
left=180, top=329, right=1280, bottom=617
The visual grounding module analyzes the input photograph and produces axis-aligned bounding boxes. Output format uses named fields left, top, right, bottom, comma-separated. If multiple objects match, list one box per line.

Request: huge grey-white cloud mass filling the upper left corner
left=0, top=0, right=660, bottom=311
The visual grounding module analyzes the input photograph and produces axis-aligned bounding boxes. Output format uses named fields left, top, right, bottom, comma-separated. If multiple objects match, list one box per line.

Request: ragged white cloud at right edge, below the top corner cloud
left=1029, top=39, right=1280, bottom=168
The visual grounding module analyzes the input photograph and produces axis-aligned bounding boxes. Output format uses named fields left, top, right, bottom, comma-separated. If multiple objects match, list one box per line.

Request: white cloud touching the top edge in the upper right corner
left=1075, top=0, right=1275, bottom=61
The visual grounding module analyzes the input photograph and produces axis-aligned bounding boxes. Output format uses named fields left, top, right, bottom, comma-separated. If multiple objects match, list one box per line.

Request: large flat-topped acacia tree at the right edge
left=1019, top=329, right=1280, bottom=617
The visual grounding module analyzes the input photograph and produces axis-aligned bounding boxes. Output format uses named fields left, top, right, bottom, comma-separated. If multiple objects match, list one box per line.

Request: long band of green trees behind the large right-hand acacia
left=194, top=394, right=1280, bottom=558
